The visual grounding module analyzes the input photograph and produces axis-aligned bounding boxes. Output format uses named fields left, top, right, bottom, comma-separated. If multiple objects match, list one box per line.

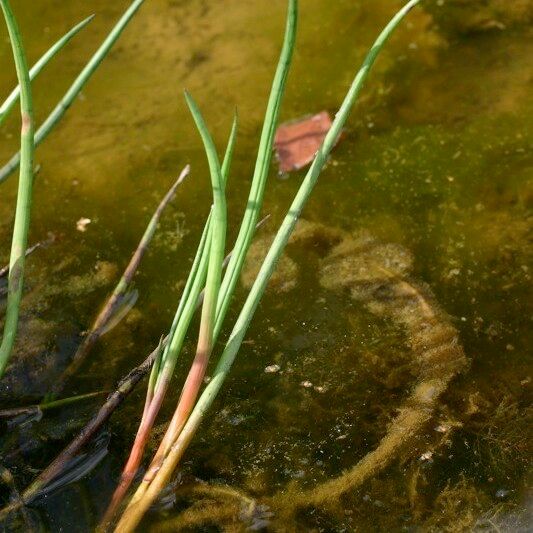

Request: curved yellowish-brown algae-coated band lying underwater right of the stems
left=149, top=221, right=467, bottom=531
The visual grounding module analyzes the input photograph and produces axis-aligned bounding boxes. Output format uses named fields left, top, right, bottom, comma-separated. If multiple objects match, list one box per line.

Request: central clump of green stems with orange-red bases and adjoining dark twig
left=2, top=0, right=425, bottom=531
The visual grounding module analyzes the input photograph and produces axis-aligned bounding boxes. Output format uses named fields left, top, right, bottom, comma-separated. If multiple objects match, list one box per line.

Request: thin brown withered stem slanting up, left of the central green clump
left=54, top=165, right=190, bottom=393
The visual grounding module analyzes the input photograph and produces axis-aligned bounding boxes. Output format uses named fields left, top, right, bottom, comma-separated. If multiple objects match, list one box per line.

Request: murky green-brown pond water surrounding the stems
left=0, top=0, right=533, bottom=531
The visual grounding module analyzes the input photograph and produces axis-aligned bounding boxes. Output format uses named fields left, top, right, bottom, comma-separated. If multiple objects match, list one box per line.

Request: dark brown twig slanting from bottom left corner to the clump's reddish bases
left=0, top=337, right=168, bottom=520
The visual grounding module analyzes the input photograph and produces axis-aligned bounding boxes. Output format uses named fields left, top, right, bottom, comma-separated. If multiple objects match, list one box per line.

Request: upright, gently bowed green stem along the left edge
left=0, top=0, right=34, bottom=378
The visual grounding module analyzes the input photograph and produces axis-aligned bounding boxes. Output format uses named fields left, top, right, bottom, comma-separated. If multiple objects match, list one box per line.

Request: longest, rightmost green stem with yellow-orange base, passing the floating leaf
left=115, top=0, right=420, bottom=533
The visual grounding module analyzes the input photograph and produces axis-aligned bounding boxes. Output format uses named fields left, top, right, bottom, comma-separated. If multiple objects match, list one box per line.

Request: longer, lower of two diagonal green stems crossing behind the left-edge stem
left=0, top=0, right=144, bottom=183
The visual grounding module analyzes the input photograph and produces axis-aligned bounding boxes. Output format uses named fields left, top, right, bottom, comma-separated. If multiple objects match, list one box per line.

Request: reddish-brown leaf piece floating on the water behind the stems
left=274, top=111, right=331, bottom=172
